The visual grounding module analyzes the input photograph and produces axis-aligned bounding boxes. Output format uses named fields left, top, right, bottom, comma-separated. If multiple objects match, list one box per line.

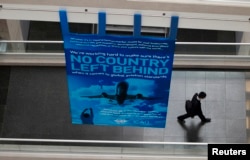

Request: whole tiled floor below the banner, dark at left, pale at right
left=2, top=67, right=247, bottom=143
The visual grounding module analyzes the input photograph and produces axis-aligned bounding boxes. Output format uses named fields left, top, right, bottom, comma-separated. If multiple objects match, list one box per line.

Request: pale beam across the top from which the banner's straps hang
left=0, top=0, right=250, bottom=32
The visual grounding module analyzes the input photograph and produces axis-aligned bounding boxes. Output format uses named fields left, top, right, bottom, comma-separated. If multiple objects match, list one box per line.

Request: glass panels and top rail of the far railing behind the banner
left=0, top=41, right=250, bottom=56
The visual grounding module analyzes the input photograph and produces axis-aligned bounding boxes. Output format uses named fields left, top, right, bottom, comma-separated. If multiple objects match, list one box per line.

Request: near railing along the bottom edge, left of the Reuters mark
left=0, top=138, right=207, bottom=160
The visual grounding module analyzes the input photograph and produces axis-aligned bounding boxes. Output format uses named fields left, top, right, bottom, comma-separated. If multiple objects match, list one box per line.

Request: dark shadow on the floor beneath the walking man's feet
left=179, top=121, right=205, bottom=142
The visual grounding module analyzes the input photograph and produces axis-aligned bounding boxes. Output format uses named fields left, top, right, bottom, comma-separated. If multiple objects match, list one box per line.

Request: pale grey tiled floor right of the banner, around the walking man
left=164, top=71, right=246, bottom=143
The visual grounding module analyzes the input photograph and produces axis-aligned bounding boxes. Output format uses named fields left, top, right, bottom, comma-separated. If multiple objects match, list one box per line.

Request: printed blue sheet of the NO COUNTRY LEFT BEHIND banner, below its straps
left=60, top=10, right=178, bottom=128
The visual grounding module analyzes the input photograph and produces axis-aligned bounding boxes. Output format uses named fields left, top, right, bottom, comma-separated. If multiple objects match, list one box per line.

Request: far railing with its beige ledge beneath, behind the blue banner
left=0, top=40, right=250, bottom=70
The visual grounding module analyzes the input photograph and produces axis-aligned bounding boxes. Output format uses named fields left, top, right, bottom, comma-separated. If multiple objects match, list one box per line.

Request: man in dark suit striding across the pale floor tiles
left=177, top=92, right=211, bottom=122
